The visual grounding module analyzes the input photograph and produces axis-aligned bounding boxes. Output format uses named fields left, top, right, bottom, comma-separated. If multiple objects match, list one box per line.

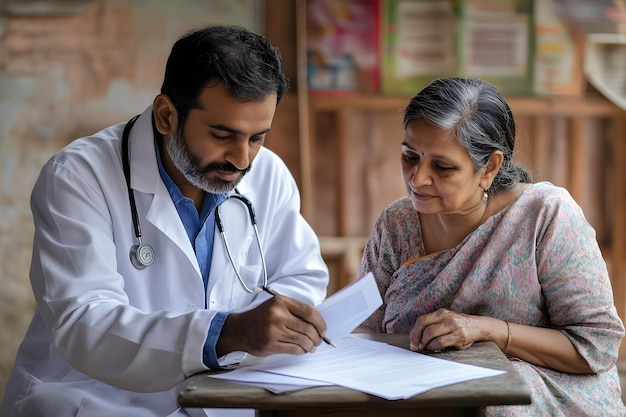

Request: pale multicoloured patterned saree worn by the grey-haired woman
left=361, top=182, right=626, bottom=417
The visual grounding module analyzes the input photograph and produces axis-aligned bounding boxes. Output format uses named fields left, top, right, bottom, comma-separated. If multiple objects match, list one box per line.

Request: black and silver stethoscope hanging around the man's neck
left=122, top=115, right=274, bottom=294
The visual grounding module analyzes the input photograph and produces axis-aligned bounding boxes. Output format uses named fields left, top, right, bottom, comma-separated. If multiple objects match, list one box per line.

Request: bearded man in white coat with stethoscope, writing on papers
left=0, top=26, right=328, bottom=417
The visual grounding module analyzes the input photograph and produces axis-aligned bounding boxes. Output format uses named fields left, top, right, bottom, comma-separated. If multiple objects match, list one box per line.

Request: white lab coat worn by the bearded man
left=0, top=107, right=328, bottom=417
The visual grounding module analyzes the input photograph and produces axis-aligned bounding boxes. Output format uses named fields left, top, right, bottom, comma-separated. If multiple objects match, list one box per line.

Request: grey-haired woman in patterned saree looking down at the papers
left=361, top=78, right=626, bottom=417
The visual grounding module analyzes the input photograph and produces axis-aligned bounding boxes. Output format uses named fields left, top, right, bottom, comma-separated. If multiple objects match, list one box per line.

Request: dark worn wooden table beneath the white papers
left=178, top=334, right=530, bottom=417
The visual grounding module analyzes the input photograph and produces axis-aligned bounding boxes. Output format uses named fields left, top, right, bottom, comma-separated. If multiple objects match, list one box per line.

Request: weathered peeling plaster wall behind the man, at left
left=0, top=0, right=260, bottom=396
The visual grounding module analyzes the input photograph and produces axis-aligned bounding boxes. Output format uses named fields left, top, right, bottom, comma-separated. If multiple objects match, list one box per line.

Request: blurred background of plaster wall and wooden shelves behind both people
left=0, top=0, right=626, bottom=396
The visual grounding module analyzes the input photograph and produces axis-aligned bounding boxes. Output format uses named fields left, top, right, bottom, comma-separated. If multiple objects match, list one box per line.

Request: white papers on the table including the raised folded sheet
left=211, top=273, right=504, bottom=400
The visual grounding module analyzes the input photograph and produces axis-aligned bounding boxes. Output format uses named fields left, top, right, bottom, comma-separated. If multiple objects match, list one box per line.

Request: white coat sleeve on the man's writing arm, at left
left=30, top=148, right=213, bottom=392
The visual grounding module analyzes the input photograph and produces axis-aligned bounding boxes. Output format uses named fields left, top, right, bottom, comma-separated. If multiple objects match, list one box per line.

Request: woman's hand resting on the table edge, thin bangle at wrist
left=409, top=308, right=506, bottom=350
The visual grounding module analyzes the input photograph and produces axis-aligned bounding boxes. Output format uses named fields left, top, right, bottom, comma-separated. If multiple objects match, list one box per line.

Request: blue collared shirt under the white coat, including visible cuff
left=154, top=139, right=228, bottom=369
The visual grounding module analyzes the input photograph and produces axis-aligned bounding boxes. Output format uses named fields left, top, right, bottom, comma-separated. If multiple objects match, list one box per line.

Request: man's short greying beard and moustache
left=167, top=129, right=251, bottom=194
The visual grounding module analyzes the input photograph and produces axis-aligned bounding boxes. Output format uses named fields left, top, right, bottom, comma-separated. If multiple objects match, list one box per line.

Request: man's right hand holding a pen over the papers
left=216, top=295, right=326, bottom=356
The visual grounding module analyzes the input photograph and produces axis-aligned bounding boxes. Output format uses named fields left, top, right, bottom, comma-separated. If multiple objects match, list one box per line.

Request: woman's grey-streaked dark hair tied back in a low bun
left=404, top=78, right=532, bottom=194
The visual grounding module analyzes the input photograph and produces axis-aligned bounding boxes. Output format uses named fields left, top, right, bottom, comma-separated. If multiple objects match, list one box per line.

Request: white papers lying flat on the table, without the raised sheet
left=212, top=337, right=504, bottom=400
